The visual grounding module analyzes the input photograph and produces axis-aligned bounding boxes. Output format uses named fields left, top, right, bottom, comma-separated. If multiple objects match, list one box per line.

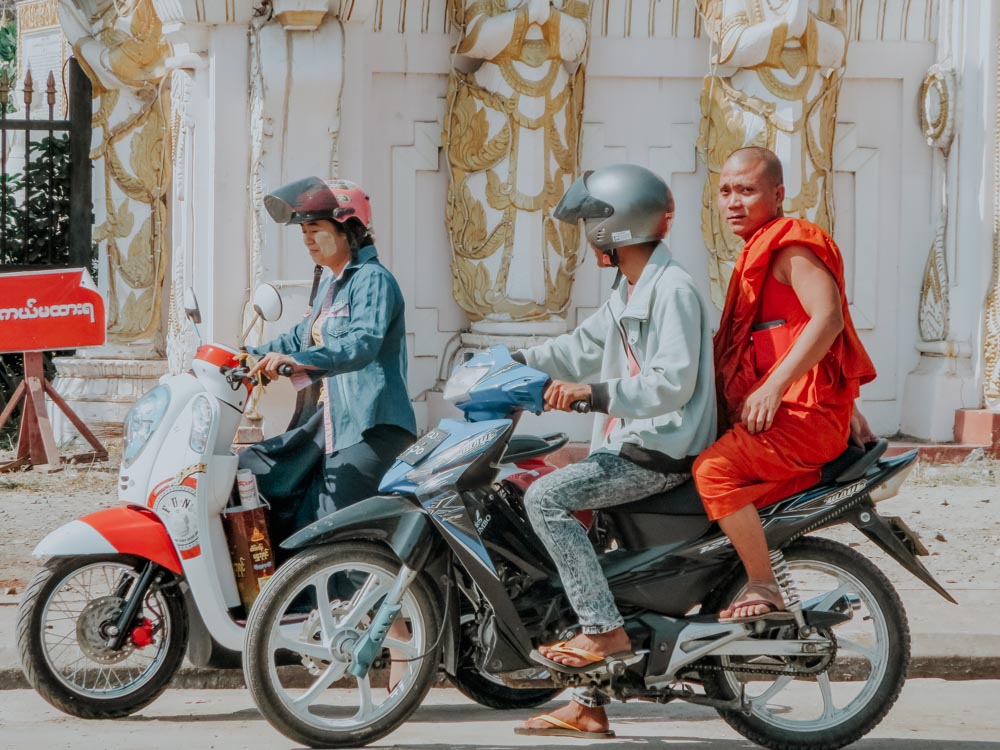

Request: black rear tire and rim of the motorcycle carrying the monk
left=701, top=537, right=910, bottom=750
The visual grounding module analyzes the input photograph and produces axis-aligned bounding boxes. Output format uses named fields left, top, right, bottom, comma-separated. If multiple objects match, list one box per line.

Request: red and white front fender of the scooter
left=32, top=505, right=183, bottom=574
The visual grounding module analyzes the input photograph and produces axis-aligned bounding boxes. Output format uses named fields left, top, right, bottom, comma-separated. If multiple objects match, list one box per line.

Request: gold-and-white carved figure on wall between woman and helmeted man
left=444, top=0, right=590, bottom=333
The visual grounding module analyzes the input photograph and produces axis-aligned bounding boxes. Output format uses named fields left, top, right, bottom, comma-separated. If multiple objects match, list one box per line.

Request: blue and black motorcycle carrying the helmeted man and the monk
left=243, top=347, right=954, bottom=749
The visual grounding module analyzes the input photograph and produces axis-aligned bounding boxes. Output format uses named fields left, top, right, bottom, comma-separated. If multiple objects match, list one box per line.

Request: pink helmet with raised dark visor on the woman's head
left=264, top=177, right=372, bottom=231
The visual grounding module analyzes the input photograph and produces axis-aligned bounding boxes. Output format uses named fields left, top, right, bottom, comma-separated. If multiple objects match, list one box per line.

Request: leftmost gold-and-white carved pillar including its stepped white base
left=49, top=0, right=171, bottom=439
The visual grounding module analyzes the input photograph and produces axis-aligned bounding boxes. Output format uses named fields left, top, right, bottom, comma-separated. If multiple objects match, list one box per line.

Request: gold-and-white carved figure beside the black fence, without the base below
left=59, top=0, right=171, bottom=349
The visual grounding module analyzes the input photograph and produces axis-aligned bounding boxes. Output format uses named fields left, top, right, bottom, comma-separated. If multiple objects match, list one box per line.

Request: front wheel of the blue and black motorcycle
left=243, top=541, right=441, bottom=747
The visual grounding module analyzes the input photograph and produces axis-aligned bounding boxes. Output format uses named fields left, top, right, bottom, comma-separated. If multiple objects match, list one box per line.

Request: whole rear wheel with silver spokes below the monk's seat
left=701, top=537, right=910, bottom=750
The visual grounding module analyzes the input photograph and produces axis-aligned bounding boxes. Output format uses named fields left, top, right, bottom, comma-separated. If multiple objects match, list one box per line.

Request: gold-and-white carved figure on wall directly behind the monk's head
left=698, top=0, right=848, bottom=308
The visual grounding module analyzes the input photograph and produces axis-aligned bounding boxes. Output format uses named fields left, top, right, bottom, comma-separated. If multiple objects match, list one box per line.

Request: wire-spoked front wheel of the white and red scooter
left=16, top=555, right=188, bottom=719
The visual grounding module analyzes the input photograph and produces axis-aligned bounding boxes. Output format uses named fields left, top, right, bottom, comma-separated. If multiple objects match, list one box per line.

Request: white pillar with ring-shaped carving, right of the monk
left=900, top=0, right=995, bottom=443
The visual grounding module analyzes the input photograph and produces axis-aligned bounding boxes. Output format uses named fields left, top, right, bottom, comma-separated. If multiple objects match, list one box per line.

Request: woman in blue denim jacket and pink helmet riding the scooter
left=240, top=177, right=416, bottom=542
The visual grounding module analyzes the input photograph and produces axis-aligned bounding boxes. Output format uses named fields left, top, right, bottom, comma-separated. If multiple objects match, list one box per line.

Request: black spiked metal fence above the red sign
left=0, top=59, right=95, bottom=269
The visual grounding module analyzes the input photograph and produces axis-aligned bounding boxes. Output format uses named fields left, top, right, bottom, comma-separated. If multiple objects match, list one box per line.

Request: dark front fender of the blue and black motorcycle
left=281, top=495, right=435, bottom=570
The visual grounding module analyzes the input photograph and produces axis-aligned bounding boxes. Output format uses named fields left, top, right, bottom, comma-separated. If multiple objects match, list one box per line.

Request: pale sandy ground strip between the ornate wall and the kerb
left=0, top=454, right=1000, bottom=604
